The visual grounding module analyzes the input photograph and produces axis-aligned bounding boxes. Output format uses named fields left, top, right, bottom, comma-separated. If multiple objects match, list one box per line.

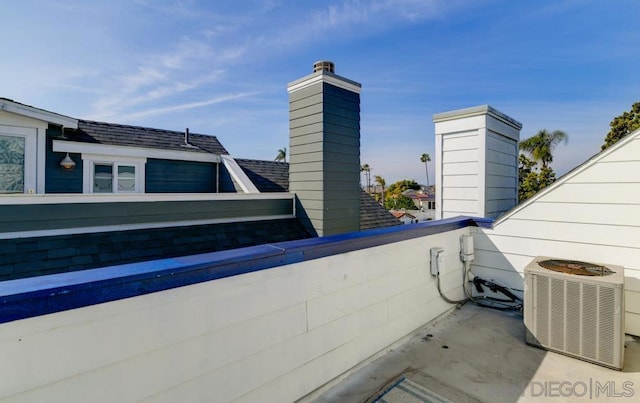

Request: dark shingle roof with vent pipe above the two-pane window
left=59, top=120, right=228, bottom=155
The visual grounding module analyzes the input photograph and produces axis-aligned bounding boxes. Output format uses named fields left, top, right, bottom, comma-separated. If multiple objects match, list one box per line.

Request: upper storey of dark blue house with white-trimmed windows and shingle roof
left=0, top=98, right=228, bottom=194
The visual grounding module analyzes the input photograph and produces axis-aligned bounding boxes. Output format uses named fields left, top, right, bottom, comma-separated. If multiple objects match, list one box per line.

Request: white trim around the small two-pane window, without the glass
left=82, top=154, right=147, bottom=194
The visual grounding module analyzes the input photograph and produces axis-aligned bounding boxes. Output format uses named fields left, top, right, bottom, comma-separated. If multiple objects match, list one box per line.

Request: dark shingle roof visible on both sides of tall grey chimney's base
left=236, top=159, right=401, bottom=230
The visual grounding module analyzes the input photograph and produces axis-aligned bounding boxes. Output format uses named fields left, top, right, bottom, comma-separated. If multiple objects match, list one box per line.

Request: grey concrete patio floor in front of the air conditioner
left=305, top=304, right=640, bottom=403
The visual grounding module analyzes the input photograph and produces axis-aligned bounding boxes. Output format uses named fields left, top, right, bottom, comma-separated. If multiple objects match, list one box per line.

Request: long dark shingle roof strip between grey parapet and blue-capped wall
left=0, top=218, right=311, bottom=281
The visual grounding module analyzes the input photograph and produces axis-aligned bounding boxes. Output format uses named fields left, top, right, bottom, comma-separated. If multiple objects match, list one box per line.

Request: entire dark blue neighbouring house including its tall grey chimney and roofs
left=0, top=64, right=399, bottom=281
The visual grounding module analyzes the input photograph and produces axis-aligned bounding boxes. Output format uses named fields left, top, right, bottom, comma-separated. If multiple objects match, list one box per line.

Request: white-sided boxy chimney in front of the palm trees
left=433, top=105, right=522, bottom=220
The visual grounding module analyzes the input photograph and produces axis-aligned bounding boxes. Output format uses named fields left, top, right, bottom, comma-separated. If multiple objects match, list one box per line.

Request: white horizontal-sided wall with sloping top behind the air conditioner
left=474, top=132, right=640, bottom=335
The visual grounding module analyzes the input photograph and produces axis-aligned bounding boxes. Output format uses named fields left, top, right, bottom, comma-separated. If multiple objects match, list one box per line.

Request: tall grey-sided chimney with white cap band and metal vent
left=287, top=61, right=361, bottom=236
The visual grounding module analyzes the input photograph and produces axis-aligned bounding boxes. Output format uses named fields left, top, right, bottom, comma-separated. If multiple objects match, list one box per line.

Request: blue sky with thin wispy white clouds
left=0, top=0, right=640, bottom=183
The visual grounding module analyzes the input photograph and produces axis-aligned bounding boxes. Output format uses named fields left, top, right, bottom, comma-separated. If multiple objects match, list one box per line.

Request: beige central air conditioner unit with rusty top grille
left=524, top=256, right=624, bottom=369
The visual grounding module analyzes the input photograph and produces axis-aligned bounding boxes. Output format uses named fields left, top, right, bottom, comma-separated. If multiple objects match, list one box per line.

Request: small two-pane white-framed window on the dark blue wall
left=82, top=155, right=145, bottom=193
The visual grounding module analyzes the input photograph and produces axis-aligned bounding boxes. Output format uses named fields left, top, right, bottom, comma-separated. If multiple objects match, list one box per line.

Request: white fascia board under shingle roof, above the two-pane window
left=53, top=140, right=220, bottom=163
